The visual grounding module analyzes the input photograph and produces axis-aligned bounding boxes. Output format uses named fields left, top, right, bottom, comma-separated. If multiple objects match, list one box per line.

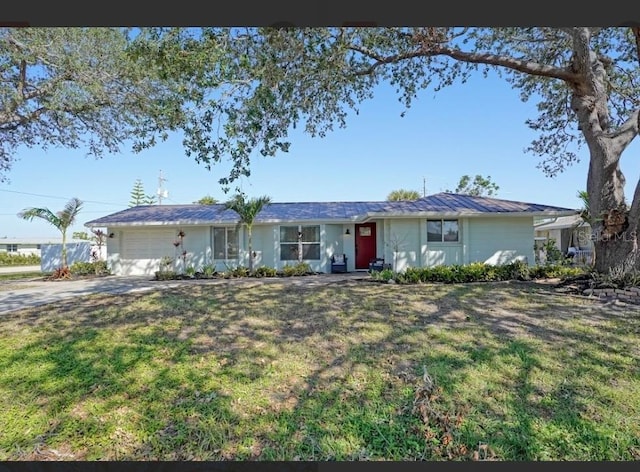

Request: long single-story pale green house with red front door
left=85, top=193, right=576, bottom=275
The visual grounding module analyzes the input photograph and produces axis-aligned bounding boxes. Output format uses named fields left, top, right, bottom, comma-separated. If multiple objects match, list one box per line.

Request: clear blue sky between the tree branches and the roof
left=0, top=68, right=640, bottom=238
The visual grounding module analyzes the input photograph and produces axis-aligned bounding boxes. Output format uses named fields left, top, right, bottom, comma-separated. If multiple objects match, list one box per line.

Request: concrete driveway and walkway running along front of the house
left=0, top=272, right=370, bottom=314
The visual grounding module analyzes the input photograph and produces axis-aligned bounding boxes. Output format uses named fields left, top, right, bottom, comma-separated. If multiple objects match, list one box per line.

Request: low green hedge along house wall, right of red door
left=371, top=261, right=585, bottom=284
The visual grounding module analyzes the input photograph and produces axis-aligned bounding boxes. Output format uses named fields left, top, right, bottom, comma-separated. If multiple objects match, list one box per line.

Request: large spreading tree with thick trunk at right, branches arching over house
left=148, top=27, right=640, bottom=271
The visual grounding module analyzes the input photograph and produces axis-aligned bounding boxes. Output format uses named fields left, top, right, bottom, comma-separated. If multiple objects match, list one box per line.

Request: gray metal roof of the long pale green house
left=85, top=193, right=576, bottom=227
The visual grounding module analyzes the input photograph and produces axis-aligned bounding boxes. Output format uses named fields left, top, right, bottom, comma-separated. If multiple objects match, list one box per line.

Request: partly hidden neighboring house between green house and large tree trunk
left=534, top=214, right=593, bottom=263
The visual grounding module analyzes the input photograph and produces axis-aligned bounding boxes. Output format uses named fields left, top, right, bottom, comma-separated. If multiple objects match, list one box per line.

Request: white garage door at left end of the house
left=120, top=229, right=176, bottom=275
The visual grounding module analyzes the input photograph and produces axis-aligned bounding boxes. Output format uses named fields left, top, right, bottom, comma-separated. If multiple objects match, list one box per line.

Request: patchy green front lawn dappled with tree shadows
left=0, top=280, right=640, bottom=460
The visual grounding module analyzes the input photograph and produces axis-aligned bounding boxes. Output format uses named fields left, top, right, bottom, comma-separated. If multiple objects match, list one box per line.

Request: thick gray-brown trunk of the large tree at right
left=570, top=28, right=640, bottom=274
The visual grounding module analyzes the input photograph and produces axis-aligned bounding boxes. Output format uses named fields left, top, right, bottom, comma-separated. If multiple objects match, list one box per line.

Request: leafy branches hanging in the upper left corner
left=0, top=27, right=179, bottom=181
